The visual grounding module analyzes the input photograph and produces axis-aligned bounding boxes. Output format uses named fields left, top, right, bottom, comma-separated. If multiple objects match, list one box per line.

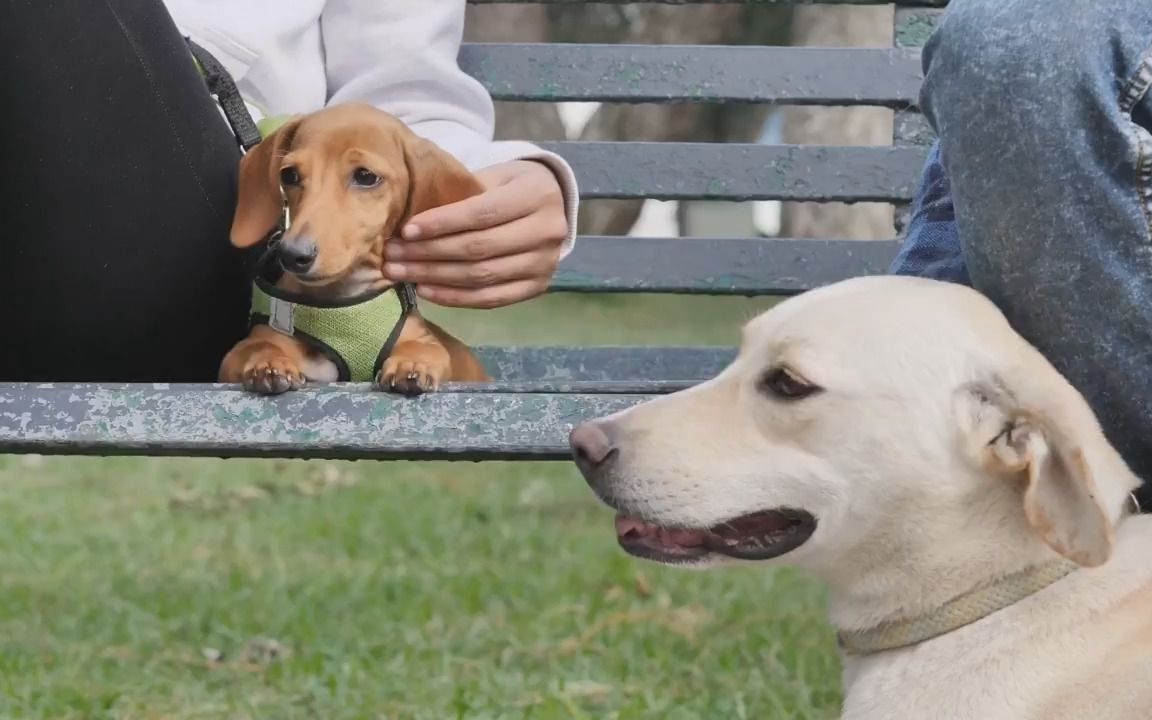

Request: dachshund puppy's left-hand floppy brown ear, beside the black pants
left=232, top=118, right=302, bottom=248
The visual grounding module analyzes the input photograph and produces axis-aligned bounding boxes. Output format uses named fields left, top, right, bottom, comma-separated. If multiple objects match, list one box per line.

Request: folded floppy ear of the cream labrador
left=960, top=371, right=1137, bottom=567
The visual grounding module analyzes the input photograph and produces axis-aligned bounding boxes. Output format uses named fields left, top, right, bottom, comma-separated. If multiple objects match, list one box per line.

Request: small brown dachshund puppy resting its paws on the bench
left=220, top=104, right=487, bottom=394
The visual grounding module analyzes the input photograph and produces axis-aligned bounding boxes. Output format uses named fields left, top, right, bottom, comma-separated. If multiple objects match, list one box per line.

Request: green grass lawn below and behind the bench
left=0, top=297, right=839, bottom=720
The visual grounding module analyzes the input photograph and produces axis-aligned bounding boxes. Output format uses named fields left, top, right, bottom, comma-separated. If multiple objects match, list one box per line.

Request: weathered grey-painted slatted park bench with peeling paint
left=0, top=0, right=947, bottom=460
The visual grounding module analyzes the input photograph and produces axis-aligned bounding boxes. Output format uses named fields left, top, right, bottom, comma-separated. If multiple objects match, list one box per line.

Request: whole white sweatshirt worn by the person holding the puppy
left=165, top=0, right=578, bottom=255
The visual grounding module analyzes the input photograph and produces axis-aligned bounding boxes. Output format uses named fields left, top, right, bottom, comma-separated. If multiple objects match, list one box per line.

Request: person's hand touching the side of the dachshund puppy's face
left=384, top=160, right=568, bottom=308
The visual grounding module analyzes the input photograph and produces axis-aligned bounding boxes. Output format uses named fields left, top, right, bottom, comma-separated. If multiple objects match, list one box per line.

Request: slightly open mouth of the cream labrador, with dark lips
left=616, top=508, right=816, bottom=564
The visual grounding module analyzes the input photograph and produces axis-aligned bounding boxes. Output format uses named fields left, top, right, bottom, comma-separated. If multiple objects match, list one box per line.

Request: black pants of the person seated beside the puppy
left=0, top=0, right=249, bottom=381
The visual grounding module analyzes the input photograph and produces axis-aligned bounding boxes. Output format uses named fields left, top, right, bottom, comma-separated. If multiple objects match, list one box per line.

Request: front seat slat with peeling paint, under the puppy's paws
left=0, top=384, right=653, bottom=460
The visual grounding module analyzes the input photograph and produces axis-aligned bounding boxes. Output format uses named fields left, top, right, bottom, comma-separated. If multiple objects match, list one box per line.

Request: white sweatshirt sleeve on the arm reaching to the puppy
left=320, top=0, right=579, bottom=255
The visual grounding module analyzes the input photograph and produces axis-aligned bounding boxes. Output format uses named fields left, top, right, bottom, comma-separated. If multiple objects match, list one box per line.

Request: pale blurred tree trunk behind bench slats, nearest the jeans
left=780, top=5, right=895, bottom=240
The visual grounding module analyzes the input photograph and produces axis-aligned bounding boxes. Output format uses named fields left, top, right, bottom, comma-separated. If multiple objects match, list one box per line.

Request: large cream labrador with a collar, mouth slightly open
left=571, top=276, right=1152, bottom=720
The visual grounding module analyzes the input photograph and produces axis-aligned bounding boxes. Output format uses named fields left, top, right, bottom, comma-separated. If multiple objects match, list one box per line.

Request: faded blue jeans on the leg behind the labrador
left=890, top=0, right=1152, bottom=495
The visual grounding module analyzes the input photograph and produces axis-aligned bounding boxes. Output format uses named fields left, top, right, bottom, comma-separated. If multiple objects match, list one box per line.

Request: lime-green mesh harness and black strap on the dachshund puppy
left=188, top=39, right=416, bottom=382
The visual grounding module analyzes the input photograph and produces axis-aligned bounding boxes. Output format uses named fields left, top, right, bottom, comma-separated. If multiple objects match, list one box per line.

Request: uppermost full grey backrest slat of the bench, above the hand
left=460, top=44, right=920, bottom=107
